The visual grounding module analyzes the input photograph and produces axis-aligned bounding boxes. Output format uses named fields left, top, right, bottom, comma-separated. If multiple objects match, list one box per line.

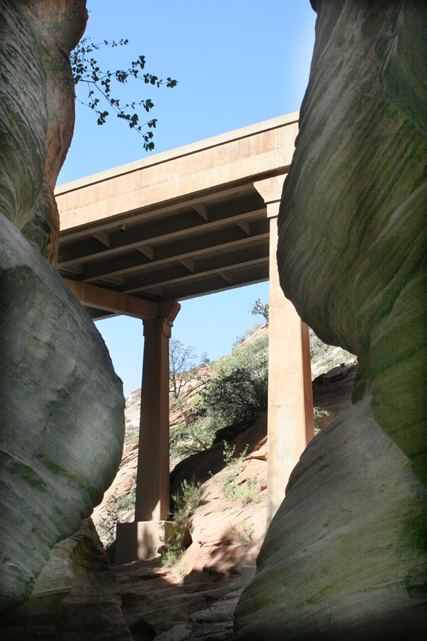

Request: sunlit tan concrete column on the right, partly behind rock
left=255, top=176, right=314, bottom=525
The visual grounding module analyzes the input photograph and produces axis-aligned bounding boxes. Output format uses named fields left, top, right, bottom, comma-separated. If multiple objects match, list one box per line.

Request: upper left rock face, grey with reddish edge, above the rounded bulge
left=0, top=0, right=87, bottom=265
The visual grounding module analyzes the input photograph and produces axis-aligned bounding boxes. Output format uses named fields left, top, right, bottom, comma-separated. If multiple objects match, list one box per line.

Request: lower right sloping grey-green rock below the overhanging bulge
left=234, top=398, right=427, bottom=641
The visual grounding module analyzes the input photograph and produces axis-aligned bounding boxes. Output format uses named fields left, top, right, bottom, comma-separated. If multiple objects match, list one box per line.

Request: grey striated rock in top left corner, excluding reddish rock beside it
left=0, top=0, right=47, bottom=229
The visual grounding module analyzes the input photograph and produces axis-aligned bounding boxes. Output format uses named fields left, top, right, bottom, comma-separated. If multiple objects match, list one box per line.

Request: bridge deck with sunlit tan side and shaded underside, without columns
left=55, top=113, right=298, bottom=318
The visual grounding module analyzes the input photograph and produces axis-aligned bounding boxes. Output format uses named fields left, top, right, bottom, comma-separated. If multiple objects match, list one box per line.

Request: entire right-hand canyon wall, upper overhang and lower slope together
left=235, top=0, right=427, bottom=641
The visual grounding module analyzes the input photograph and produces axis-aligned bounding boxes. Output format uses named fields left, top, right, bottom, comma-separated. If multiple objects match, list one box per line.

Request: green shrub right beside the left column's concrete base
left=162, top=480, right=200, bottom=574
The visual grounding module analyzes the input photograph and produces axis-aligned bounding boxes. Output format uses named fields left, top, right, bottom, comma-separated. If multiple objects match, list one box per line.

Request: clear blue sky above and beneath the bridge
left=58, top=0, right=316, bottom=396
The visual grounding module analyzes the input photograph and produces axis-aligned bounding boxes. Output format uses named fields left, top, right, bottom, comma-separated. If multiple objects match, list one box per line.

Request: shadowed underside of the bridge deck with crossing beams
left=58, top=182, right=269, bottom=318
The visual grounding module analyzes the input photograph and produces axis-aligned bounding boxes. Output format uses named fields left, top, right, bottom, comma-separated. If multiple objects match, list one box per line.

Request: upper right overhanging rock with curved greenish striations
left=278, top=0, right=427, bottom=482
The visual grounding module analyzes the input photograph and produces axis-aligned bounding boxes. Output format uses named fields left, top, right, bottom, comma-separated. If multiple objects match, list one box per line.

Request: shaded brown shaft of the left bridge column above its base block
left=135, top=318, right=172, bottom=521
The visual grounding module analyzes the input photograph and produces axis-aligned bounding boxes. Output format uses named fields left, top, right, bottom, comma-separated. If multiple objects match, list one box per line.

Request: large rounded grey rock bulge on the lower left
left=0, top=215, right=124, bottom=611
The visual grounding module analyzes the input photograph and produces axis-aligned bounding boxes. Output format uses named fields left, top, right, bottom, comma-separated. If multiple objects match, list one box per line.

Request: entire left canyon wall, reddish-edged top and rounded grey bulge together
left=0, top=0, right=124, bottom=614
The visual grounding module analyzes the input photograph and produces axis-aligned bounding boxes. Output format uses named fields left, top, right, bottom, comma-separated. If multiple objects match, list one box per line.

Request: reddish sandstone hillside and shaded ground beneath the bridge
left=88, top=326, right=357, bottom=640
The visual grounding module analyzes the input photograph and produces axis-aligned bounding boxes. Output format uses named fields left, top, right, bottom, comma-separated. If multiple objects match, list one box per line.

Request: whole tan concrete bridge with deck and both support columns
left=55, top=113, right=313, bottom=562
